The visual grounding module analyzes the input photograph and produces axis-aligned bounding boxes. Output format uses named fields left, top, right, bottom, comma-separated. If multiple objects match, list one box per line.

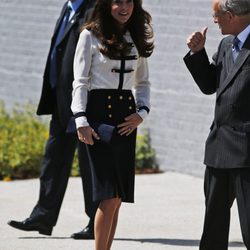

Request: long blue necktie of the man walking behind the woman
left=49, top=6, right=72, bottom=88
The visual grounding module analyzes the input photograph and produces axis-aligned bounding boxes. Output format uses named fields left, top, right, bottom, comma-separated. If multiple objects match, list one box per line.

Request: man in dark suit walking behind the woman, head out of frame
left=8, top=0, right=98, bottom=239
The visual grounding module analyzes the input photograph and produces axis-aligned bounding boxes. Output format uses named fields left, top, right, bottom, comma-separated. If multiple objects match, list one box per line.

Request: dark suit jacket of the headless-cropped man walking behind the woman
left=37, top=0, right=95, bottom=128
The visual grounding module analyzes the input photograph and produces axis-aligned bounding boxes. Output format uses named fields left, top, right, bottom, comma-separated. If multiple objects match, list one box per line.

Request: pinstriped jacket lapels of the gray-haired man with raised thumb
left=217, top=35, right=250, bottom=98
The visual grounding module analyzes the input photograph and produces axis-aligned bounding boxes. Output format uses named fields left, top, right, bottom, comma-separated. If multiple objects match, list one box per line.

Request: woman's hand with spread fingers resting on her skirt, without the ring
left=117, top=113, right=143, bottom=136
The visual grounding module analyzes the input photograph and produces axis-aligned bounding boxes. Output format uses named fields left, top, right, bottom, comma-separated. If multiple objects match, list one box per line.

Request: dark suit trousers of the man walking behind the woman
left=30, top=115, right=98, bottom=226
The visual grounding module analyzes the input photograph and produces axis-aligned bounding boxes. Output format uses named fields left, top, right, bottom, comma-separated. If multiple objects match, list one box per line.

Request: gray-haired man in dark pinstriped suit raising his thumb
left=184, top=0, right=250, bottom=250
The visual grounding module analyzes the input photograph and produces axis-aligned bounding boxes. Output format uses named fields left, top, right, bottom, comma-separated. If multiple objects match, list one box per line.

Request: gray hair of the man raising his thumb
left=220, top=0, right=250, bottom=16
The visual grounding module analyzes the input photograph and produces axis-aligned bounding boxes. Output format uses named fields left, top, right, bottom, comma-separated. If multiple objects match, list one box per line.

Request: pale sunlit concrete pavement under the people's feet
left=0, top=172, right=245, bottom=250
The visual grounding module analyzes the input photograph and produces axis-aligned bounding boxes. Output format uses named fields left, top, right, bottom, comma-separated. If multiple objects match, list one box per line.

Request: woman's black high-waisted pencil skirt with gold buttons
left=86, top=89, right=136, bottom=202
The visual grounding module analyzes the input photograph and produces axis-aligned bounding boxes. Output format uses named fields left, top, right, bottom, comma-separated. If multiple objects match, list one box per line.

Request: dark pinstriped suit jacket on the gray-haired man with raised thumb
left=184, top=36, right=250, bottom=168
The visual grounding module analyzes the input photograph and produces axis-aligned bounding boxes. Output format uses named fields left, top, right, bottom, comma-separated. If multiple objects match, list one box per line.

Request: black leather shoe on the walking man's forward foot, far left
left=7, top=218, right=53, bottom=235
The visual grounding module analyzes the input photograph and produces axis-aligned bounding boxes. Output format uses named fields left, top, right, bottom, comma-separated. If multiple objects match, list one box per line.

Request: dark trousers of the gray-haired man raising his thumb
left=199, top=167, right=250, bottom=250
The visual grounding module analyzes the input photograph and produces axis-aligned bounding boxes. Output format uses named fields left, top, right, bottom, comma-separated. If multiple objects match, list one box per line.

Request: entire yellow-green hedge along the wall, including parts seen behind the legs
left=0, top=105, right=158, bottom=180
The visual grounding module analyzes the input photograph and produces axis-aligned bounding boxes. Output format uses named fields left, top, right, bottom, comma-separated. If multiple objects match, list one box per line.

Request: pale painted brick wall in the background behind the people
left=0, top=0, right=225, bottom=175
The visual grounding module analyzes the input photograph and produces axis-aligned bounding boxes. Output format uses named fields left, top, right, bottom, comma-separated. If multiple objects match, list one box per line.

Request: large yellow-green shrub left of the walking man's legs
left=0, top=104, right=48, bottom=178
